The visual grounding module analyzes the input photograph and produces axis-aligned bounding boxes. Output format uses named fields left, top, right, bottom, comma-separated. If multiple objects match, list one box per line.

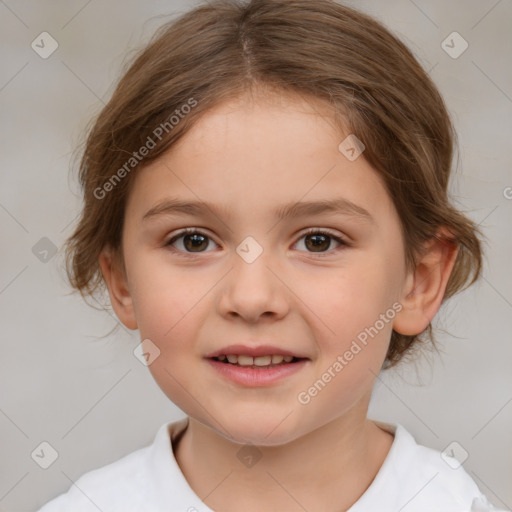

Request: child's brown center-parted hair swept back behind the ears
left=61, top=0, right=482, bottom=368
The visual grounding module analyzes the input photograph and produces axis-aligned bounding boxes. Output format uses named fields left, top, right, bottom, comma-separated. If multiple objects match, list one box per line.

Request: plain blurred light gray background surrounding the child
left=0, top=0, right=512, bottom=511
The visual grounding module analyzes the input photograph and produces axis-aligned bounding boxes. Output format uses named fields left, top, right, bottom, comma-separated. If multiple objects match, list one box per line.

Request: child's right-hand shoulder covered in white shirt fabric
left=350, top=421, right=502, bottom=512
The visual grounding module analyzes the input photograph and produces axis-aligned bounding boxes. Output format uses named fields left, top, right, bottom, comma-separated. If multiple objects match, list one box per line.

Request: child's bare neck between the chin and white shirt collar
left=174, top=415, right=393, bottom=512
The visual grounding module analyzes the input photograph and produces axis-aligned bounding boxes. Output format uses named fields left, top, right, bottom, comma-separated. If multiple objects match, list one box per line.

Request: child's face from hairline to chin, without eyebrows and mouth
left=109, top=91, right=412, bottom=445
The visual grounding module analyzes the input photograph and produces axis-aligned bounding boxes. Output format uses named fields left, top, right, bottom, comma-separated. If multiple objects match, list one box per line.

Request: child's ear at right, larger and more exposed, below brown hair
left=393, top=228, right=458, bottom=335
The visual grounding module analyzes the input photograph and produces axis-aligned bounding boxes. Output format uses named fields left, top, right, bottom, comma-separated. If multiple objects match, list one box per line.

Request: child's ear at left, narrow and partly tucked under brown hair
left=99, top=247, right=137, bottom=330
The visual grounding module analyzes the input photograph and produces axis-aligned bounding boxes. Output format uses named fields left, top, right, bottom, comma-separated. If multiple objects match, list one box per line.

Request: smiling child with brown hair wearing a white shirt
left=40, top=0, right=508, bottom=512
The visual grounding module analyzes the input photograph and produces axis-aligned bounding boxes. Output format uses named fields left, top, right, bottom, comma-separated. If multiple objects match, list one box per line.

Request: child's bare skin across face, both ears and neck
left=100, top=90, right=457, bottom=512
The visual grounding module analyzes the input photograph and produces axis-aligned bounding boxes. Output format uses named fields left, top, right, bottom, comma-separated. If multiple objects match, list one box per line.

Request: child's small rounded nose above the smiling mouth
left=217, top=245, right=291, bottom=323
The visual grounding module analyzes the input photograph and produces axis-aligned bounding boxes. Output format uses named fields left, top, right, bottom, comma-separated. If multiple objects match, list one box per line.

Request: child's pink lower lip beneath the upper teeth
left=204, top=359, right=308, bottom=387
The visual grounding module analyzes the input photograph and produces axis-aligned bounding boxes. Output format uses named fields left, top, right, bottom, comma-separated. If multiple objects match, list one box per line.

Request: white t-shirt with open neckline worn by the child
left=38, top=418, right=508, bottom=512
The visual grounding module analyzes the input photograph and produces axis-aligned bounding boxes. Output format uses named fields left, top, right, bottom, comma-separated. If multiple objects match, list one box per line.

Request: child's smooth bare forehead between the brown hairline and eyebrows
left=128, top=92, right=394, bottom=228
